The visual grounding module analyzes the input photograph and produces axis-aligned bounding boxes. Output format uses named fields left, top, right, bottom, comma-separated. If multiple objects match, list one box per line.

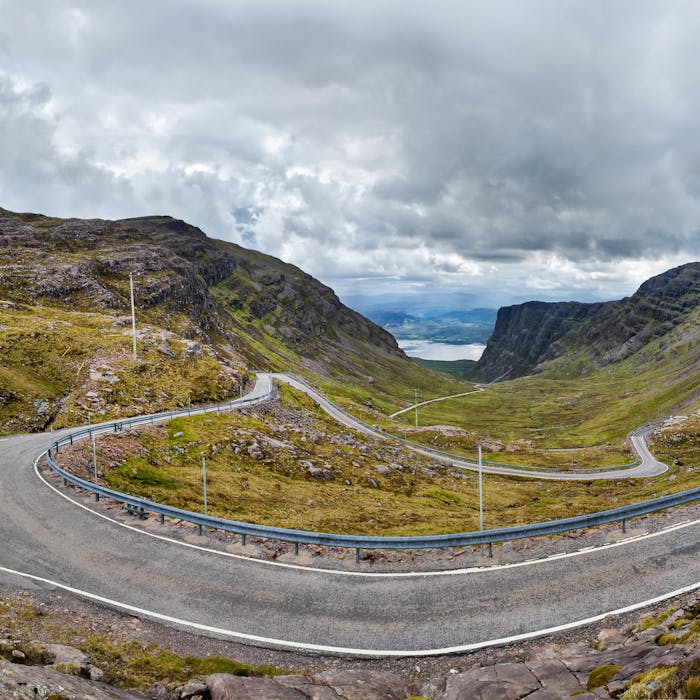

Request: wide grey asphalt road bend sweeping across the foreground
left=0, top=378, right=700, bottom=656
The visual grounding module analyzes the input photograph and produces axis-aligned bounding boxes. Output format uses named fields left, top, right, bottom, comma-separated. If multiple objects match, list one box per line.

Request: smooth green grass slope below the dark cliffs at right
left=394, top=308, right=700, bottom=452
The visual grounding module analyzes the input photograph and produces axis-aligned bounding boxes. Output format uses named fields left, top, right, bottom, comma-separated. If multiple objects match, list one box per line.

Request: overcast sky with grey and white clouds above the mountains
left=0, top=0, right=700, bottom=306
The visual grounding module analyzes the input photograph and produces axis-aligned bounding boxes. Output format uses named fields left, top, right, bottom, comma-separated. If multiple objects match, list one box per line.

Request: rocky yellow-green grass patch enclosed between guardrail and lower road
left=56, top=386, right=700, bottom=535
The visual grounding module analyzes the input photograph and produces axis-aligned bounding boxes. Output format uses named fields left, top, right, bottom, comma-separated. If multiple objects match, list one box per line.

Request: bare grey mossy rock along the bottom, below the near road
left=0, top=595, right=700, bottom=700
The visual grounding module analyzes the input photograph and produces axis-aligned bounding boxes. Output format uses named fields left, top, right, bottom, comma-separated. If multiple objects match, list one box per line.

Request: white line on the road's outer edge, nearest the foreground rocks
left=0, top=566, right=700, bottom=657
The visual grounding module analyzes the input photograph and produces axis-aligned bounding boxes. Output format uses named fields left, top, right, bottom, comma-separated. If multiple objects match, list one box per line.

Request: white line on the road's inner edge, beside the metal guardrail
left=34, top=452, right=700, bottom=578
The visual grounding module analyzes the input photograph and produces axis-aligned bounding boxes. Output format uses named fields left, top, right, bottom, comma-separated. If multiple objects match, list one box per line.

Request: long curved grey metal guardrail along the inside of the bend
left=47, top=392, right=700, bottom=559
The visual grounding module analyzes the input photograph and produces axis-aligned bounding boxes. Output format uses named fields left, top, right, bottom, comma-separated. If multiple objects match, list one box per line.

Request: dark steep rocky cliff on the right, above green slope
left=475, top=263, right=700, bottom=381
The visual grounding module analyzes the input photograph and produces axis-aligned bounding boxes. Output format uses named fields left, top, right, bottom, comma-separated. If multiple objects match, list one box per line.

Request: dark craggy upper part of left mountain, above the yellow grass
left=0, top=209, right=404, bottom=366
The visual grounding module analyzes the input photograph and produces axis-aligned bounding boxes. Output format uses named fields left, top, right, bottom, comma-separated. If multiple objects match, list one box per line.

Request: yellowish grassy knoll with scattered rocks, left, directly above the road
left=0, top=302, right=249, bottom=433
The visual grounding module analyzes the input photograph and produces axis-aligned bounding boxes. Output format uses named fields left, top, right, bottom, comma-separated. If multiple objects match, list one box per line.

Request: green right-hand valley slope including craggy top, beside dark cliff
left=400, top=274, right=700, bottom=454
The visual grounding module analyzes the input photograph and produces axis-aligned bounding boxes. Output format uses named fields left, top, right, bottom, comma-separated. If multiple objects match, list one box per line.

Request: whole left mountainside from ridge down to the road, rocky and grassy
left=0, top=209, right=464, bottom=432
